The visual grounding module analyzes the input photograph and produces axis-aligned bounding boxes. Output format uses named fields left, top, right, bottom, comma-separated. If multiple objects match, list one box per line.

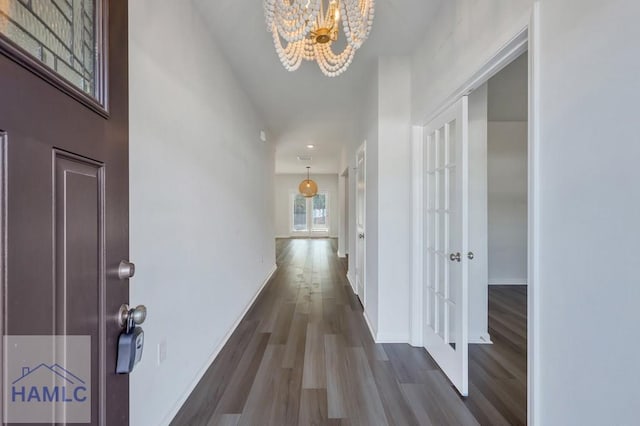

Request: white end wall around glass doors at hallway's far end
left=274, top=173, right=340, bottom=238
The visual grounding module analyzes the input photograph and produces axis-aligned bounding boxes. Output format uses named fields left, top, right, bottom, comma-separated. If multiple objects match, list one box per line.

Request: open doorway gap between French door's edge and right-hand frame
left=467, top=52, right=529, bottom=425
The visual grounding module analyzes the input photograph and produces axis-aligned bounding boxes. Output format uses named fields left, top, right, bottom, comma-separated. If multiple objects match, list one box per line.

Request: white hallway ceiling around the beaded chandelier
left=193, top=0, right=442, bottom=173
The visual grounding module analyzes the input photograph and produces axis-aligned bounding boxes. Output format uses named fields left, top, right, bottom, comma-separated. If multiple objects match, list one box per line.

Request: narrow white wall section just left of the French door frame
left=378, top=57, right=412, bottom=342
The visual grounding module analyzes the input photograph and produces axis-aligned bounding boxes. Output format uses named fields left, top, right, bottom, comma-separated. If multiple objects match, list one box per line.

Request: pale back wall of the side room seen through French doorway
left=488, top=121, right=528, bottom=285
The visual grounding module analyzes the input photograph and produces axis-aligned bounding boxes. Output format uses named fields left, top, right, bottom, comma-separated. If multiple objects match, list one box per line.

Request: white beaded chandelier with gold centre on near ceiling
left=264, top=0, right=375, bottom=77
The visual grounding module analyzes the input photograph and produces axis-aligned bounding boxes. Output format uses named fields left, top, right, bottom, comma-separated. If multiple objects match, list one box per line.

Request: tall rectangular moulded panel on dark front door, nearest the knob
left=53, top=151, right=106, bottom=422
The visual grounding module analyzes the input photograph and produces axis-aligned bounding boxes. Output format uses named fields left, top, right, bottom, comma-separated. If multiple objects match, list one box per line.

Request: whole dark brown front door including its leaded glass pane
left=0, top=0, right=129, bottom=425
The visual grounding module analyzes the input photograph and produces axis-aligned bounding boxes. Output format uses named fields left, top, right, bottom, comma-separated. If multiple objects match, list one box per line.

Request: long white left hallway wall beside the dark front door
left=129, top=0, right=275, bottom=426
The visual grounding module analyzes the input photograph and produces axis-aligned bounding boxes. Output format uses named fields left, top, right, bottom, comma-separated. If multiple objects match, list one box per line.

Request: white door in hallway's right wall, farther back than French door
left=356, top=146, right=367, bottom=306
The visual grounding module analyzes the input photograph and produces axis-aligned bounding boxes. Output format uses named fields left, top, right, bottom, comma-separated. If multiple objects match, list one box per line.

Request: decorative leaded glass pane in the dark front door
left=0, top=0, right=100, bottom=99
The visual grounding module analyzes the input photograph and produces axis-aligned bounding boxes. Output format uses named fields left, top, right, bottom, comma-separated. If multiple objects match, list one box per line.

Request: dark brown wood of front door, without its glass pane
left=0, top=0, right=129, bottom=425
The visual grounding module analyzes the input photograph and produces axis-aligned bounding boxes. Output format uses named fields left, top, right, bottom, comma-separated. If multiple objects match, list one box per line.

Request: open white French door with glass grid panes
left=423, top=97, right=469, bottom=396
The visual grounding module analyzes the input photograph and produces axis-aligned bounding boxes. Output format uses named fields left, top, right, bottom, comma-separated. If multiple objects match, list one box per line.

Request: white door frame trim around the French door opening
left=410, top=2, right=541, bottom=425
